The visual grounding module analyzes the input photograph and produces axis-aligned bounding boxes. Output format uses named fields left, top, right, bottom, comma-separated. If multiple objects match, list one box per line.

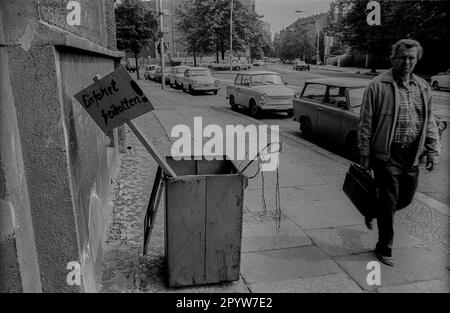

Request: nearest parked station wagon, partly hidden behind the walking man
left=293, top=78, right=447, bottom=160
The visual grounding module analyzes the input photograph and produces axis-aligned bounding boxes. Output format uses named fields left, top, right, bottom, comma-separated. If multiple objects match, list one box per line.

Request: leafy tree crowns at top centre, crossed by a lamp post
left=177, top=0, right=264, bottom=61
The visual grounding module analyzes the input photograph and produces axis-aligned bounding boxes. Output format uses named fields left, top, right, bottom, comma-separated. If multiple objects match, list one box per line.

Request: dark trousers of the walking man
left=372, top=145, right=419, bottom=256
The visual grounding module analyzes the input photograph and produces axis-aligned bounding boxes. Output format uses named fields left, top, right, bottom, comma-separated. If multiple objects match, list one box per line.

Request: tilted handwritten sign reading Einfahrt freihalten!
left=74, top=67, right=153, bottom=132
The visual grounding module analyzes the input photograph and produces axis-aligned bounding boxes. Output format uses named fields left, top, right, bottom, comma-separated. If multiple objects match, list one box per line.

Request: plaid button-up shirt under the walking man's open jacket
left=392, top=80, right=425, bottom=144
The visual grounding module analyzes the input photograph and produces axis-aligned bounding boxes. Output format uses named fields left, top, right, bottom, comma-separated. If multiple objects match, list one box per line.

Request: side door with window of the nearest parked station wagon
left=317, top=86, right=347, bottom=142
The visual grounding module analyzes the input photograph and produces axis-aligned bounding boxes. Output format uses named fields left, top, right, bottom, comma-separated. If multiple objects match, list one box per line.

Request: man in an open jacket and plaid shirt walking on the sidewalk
left=359, top=39, right=439, bottom=266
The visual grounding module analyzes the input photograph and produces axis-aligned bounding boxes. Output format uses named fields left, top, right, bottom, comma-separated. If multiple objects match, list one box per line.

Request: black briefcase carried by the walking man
left=343, top=164, right=378, bottom=218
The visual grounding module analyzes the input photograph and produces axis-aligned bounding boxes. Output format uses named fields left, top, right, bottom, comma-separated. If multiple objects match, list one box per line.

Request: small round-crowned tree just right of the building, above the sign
left=115, top=0, right=158, bottom=79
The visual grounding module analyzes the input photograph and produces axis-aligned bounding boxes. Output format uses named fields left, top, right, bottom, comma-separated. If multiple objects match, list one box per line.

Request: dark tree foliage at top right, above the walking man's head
left=329, top=0, right=450, bottom=72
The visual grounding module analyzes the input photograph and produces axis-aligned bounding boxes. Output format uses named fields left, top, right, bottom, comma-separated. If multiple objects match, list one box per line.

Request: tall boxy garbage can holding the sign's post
left=165, top=157, right=247, bottom=287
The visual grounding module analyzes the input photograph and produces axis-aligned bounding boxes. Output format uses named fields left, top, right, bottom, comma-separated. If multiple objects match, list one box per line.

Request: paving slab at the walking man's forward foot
left=306, top=222, right=422, bottom=256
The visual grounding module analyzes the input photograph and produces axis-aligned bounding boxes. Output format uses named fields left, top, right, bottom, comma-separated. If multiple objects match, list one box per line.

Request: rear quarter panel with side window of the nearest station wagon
left=295, top=83, right=327, bottom=134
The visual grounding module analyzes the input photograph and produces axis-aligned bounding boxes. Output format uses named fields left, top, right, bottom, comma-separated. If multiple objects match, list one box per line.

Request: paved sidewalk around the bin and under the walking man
left=100, top=81, right=450, bottom=292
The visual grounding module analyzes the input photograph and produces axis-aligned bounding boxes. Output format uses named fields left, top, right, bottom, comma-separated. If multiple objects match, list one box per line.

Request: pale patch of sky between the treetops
left=255, top=0, right=332, bottom=36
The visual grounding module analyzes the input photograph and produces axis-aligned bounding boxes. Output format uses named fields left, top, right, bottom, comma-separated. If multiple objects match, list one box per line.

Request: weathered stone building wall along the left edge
left=0, top=0, right=122, bottom=292
